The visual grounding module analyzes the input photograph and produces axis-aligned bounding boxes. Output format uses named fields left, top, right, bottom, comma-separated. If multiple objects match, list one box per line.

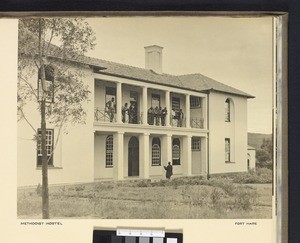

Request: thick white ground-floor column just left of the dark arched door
left=113, top=132, right=124, bottom=180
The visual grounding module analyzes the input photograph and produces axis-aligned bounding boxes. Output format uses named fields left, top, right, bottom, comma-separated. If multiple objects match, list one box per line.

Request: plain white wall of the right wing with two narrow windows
left=209, top=92, right=247, bottom=174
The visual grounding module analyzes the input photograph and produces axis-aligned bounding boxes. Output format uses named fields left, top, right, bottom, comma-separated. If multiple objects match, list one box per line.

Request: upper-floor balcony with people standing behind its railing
left=94, top=80, right=206, bottom=129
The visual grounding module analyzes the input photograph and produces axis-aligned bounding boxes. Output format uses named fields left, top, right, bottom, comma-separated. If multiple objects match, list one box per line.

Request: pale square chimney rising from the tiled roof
left=145, top=45, right=163, bottom=74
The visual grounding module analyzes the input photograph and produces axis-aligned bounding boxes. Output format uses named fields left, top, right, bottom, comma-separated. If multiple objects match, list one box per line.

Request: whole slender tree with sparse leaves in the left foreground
left=18, top=18, right=95, bottom=218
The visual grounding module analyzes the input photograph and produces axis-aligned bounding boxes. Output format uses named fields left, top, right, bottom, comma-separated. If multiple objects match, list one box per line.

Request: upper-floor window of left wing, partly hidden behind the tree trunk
left=38, top=65, right=54, bottom=103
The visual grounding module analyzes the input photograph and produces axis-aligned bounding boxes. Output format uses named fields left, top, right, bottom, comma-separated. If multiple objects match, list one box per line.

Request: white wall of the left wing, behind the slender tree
left=17, top=64, right=94, bottom=186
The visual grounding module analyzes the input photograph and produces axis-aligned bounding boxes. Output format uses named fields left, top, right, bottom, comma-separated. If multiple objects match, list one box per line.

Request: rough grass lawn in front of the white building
left=18, top=177, right=272, bottom=219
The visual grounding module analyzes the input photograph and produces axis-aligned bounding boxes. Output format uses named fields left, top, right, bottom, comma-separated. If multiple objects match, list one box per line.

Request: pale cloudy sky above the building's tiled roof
left=87, top=17, right=273, bottom=134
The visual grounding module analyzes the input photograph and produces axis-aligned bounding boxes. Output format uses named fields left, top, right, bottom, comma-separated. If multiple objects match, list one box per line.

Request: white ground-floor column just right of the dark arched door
left=139, top=133, right=150, bottom=179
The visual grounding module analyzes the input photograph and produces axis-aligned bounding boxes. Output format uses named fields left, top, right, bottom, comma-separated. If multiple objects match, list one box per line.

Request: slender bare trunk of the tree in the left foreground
left=39, top=19, right=50, bottom=219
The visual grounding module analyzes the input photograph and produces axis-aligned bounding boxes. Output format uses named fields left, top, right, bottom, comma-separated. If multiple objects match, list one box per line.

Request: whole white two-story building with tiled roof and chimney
left=18, top=45, right=253, bottom=186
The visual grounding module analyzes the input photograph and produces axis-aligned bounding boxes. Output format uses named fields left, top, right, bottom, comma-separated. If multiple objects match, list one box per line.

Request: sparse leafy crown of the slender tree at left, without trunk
left=18, top=18, right=95, bottom=133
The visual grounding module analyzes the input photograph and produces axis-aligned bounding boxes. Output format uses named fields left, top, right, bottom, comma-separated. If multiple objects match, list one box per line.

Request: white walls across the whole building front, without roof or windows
left=18, top=63, right=247, bottom=186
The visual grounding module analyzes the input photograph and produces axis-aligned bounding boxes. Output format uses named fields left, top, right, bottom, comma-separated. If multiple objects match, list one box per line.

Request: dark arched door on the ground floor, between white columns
left=128, top=137, right=139, bottom=176
